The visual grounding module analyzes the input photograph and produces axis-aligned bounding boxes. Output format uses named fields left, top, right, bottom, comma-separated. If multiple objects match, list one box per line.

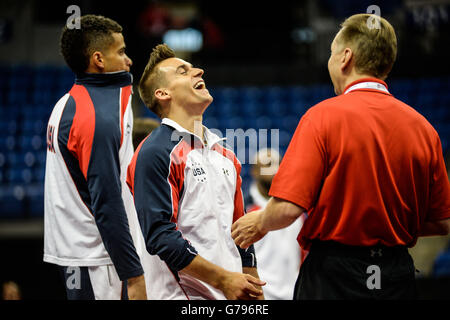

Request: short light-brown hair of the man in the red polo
left=337, top=13, right=397, bottom=79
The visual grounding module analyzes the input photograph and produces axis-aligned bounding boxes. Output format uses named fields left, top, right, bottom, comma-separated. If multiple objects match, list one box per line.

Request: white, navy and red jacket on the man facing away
left=44, top=71, right=143, bottom=280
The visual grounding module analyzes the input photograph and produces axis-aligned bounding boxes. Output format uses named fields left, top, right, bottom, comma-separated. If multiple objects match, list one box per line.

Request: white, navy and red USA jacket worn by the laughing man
left=127, top=118, right=256, bottom=299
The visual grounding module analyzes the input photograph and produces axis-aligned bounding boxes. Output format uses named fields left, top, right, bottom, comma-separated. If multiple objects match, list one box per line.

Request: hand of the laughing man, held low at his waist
left=217, top=272, right=266, bottom=300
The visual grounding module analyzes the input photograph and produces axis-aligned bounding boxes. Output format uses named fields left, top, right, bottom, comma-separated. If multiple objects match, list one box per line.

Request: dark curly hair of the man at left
left=60, top=14, right=122, bottom=74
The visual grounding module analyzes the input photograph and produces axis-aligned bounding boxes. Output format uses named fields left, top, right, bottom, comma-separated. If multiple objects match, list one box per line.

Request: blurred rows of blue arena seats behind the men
left=0, top=65, right=450, bottom=219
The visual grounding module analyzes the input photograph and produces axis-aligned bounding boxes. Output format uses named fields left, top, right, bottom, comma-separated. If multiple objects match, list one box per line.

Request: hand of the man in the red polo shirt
left=231, top=211, right=267, bottom=249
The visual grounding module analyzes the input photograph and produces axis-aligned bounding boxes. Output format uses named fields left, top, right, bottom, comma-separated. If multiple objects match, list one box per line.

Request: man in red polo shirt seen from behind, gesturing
left=232, top=14, right=450, bottom=299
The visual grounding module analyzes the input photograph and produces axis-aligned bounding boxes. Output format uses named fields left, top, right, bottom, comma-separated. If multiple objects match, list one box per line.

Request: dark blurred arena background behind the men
left=0, top=0, right=450, bottom=300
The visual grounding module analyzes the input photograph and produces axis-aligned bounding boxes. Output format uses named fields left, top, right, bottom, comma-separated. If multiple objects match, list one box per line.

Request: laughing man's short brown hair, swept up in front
left=139, top=44, right=175, bottom=117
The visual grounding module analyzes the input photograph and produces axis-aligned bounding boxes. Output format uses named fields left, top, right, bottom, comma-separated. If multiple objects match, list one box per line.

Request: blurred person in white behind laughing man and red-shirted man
left=245, top=148, right=306, bottom=300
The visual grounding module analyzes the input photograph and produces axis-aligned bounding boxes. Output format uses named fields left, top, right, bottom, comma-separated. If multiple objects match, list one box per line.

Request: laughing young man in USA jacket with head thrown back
left=127, top=45, right=264, bottom=299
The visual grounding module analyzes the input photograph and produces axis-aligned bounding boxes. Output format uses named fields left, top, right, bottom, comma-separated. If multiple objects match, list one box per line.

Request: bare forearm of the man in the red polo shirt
left=260, top=198, right=305, bottom=233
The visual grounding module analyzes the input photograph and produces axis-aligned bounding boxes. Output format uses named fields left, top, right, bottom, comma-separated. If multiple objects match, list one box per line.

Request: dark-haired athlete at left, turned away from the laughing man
left=44, top=15, right=147, bottom=299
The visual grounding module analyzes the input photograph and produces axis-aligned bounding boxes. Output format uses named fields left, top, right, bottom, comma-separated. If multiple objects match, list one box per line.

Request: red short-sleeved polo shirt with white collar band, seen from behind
left=269, top=78, right=450, bottom=250
